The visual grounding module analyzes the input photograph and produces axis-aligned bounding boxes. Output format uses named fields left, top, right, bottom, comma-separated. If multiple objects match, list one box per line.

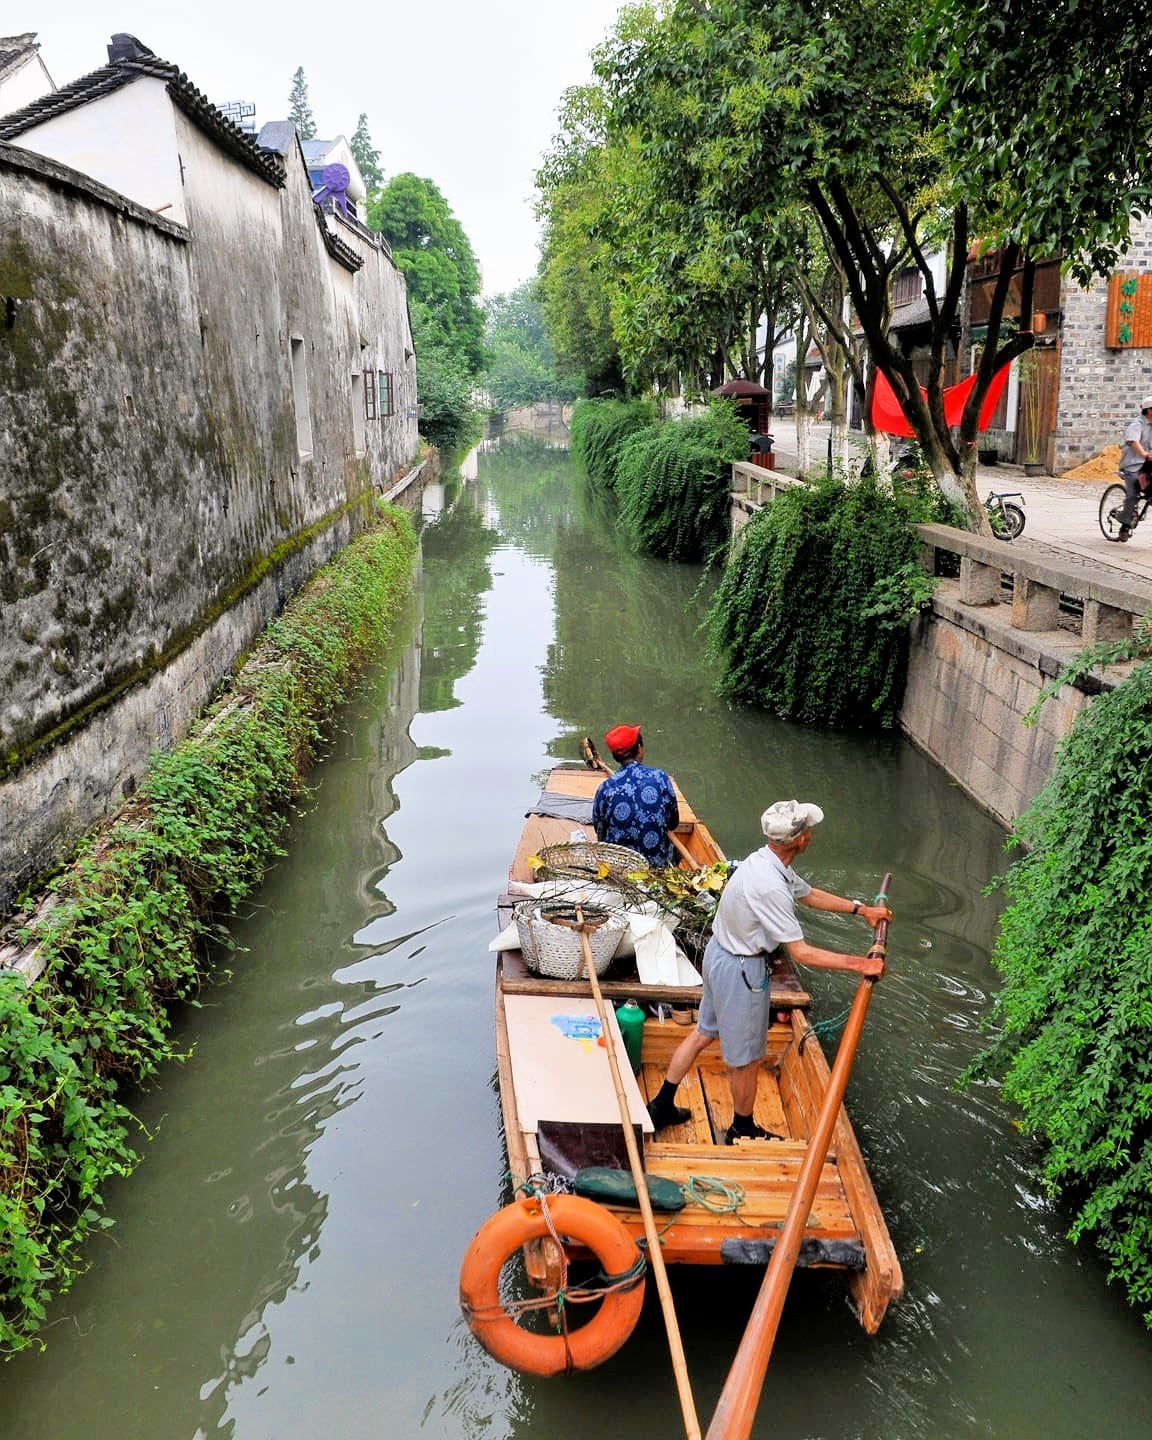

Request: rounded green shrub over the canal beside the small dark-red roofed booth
left=616, top=402, right=749, bottom=560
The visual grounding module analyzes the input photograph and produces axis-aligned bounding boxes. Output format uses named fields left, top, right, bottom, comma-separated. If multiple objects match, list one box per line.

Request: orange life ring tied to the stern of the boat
left=459, top=1195, right=644, bottom=1375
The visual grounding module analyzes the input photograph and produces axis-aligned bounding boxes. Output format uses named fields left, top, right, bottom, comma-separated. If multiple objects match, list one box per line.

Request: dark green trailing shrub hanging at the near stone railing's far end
left=707, top=477, right=933, bottom=729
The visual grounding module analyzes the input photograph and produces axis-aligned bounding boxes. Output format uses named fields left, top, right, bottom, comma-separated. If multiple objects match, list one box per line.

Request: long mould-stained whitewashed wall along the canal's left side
left=0, top=126, right=418, bottom=913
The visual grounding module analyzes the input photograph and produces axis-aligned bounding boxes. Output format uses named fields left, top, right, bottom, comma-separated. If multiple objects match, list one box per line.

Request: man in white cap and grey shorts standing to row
left=648, top=801, right=891, bottom=1145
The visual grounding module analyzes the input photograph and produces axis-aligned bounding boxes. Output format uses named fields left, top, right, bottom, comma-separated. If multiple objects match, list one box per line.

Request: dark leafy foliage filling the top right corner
left=917, top=0, right=1152, bottom=281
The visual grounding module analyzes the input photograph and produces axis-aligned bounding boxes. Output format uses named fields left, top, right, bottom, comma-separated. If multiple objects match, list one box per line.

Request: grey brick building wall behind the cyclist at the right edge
left=1051, top=219, right=1152, bottom=475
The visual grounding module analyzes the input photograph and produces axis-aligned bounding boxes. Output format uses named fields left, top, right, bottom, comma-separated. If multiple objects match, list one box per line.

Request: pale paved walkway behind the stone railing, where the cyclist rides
left=772, top=416, right=1152, bottom=582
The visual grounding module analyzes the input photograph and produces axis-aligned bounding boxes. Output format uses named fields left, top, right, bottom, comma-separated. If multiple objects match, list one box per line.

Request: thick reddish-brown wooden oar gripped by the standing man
left=706, top=874, right=891, bottom=1440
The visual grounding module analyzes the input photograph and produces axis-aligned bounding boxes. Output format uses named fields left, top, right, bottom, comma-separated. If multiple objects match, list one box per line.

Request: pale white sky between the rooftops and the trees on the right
left=18, top=0, right=621, bottom=294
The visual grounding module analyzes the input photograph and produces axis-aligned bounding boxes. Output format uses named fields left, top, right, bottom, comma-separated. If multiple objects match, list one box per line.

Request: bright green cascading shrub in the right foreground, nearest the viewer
left=969, top=662, right=1152, bottom=1326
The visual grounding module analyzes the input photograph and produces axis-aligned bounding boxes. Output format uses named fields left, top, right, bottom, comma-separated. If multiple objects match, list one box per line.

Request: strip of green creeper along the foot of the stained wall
left=0, top=507, right=416, bottom=1352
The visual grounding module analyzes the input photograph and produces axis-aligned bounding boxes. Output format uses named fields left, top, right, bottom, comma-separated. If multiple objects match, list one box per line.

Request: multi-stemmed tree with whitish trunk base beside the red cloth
left=596, top=0, right=1031, bottom=524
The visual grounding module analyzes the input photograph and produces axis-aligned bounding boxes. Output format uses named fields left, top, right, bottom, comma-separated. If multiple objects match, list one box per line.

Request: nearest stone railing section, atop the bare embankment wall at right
left=916, top=526, right=1152, bottom=645
